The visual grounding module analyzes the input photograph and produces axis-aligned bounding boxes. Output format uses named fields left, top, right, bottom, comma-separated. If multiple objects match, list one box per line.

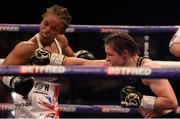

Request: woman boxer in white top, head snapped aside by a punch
left=2, top=5, right=74, bottom=118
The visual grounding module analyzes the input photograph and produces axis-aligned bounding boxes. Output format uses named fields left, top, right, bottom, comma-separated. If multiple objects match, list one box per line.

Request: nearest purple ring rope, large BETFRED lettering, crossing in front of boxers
left=0, top=65, right=180, bottom=79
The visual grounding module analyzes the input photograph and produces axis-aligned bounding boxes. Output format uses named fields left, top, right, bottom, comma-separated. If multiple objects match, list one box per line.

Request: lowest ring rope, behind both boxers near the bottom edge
left=0, top=103, right=180, bottom=114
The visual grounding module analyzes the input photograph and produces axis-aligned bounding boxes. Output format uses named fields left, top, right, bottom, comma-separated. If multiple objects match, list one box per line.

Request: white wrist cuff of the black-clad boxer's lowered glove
left=139, top=95, right=156, bottom=111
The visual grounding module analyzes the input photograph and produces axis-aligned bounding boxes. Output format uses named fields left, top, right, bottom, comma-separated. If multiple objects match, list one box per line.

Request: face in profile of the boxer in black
left=105, top=44, right=126, bottom=66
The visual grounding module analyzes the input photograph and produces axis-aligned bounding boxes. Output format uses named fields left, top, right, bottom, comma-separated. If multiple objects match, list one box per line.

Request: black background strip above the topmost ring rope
left=0, top=0, right=180, bottom=25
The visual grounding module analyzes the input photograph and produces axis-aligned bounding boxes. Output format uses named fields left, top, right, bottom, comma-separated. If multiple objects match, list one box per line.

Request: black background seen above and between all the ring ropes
left=0, top=0, right=180, bottom=117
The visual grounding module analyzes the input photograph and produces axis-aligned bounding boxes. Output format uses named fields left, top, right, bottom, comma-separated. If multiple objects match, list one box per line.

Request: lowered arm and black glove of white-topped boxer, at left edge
left=1, top=42, right=35, bottom=97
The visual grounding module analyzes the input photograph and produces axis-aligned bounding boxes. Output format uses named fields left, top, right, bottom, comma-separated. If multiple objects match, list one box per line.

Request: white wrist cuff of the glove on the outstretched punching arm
left=50, top=53, right=67, bottom=65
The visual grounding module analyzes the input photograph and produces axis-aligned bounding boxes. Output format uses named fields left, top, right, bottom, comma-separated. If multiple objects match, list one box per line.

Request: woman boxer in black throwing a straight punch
left=33, top=32, right=178, bottom=118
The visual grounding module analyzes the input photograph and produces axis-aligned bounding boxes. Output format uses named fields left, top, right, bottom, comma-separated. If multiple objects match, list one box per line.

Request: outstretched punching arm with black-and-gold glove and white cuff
left=31, top=48, right=109, bottom=66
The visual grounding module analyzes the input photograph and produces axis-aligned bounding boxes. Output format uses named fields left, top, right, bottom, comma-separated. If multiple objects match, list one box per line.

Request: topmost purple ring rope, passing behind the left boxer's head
left=0, top=24, right=179, bottom=34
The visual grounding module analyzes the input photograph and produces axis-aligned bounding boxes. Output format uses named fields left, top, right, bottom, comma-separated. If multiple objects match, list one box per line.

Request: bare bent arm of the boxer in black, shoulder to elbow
left=142, top=60, right=178, bottom=110
